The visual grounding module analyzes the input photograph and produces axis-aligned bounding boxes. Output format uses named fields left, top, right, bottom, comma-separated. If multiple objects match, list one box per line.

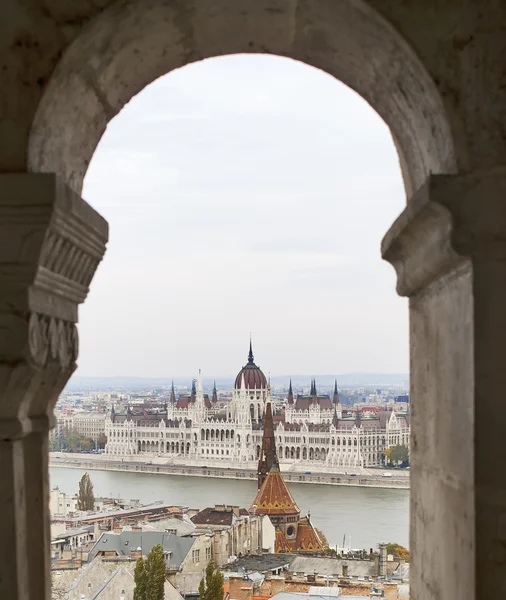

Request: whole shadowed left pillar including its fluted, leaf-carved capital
left=0, top=173, right=108, bottom=600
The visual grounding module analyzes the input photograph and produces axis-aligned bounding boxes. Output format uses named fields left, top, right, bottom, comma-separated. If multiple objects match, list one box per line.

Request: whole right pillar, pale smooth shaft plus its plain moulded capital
left=382, top=169, right=506, bottom=600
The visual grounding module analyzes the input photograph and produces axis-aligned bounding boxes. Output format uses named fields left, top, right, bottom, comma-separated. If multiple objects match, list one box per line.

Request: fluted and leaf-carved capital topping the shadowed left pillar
left=0, top=173, right=108, bottom=438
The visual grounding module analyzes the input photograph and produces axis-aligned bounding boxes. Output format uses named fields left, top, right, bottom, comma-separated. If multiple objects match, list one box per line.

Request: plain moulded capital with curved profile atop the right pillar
left=381, top=169, right=506, bottom=296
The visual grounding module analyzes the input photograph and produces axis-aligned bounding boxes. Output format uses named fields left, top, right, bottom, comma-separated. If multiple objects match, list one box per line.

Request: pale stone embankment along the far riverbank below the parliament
left=49, top=452, right=409, bottom=489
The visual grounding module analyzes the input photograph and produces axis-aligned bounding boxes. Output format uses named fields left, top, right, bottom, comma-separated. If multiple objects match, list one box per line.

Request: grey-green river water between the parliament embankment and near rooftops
left=50, top=467, right=409, bottom=548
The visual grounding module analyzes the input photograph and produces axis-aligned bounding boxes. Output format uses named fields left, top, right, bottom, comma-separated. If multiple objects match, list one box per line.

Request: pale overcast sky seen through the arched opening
left=78, top=55, right=408, bottom=377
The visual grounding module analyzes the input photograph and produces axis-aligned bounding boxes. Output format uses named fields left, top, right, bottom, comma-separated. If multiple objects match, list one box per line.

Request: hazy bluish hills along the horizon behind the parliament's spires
left=66, top=373, right=409, bottom=391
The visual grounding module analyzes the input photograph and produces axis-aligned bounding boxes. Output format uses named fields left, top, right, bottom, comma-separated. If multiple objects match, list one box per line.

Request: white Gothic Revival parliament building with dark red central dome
left=105, top=343, right=410, bottom=471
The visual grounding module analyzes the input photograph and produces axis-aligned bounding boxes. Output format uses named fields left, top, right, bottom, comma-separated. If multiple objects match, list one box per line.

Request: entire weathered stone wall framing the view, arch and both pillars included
left=0, top=0, right=506, bottom=600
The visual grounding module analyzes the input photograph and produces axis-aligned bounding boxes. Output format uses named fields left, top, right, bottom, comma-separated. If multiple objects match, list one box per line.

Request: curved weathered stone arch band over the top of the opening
left=27, top=0, right=457, bottom=202
